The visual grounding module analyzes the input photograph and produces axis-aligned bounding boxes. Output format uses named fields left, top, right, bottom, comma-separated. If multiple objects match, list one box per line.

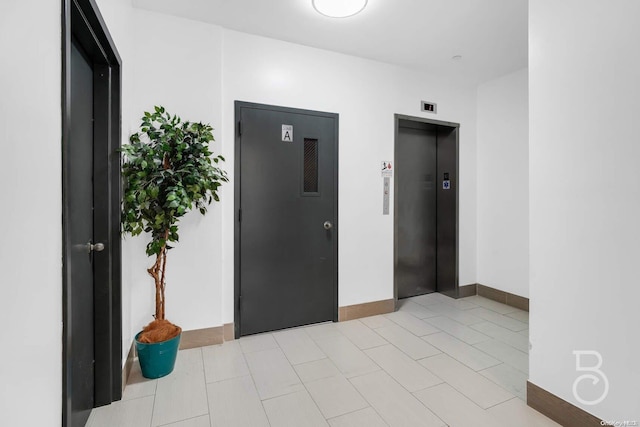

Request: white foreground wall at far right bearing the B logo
left=529, top=0, right=640, bottom=421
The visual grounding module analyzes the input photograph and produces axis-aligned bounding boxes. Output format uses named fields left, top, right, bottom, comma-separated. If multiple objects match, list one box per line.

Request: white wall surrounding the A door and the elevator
left=222, top=30, right=476, bottom=322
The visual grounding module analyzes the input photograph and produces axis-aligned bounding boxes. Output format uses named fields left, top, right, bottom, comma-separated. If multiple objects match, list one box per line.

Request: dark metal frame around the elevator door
left=393, top=114, right=460, bottom=307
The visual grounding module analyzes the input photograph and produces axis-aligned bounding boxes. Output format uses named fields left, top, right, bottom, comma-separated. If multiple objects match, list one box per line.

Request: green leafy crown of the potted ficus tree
left=118, top=106, right=228, bottom=256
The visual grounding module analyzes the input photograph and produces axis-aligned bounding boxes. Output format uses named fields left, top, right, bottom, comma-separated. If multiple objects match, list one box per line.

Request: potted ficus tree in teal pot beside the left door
left=121, top=107, right=228, bottom=378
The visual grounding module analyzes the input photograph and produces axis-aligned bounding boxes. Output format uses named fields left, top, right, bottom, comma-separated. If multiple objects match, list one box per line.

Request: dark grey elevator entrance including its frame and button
left=394, top=116, right=458, bottom=298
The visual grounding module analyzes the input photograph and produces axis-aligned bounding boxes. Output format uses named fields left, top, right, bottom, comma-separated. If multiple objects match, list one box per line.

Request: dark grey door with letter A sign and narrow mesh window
left=236, top=103, right=338, bottom=335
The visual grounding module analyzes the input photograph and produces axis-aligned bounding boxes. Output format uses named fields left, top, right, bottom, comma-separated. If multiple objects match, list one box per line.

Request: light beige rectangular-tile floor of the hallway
left=87, top=294, right=557, bottom=427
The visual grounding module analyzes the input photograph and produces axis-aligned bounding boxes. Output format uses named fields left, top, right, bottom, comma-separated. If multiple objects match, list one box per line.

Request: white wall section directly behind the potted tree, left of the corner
left=99, top=0, right=222, bottom=363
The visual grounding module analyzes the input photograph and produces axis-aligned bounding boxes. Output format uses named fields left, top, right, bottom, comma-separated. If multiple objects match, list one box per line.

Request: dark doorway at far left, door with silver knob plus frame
left=62, top=0, right=122, bottom=427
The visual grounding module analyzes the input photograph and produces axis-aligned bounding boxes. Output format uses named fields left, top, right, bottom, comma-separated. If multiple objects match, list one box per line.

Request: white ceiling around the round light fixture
left=133, top=0, right=528, bottom=85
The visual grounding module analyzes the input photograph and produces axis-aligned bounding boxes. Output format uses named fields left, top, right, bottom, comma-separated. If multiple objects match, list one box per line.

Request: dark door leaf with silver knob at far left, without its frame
left=67, top=43, right=94, bottom=426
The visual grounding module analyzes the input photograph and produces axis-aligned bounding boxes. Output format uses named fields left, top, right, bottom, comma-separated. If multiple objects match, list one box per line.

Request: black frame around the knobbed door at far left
left=61, top=0, right=122, bottom=426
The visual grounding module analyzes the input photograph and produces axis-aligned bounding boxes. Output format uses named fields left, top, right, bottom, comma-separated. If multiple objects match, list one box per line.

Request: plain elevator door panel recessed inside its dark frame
left=395, top=123, right=438, bottom=298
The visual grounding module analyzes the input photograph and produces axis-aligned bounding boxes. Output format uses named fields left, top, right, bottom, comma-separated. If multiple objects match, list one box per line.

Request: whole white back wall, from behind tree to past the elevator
left=105, top=13, right=476, bottom=334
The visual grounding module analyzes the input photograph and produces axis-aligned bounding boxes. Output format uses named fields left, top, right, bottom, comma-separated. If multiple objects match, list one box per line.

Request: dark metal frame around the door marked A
left=233, top=101, right=340, bottom=339
